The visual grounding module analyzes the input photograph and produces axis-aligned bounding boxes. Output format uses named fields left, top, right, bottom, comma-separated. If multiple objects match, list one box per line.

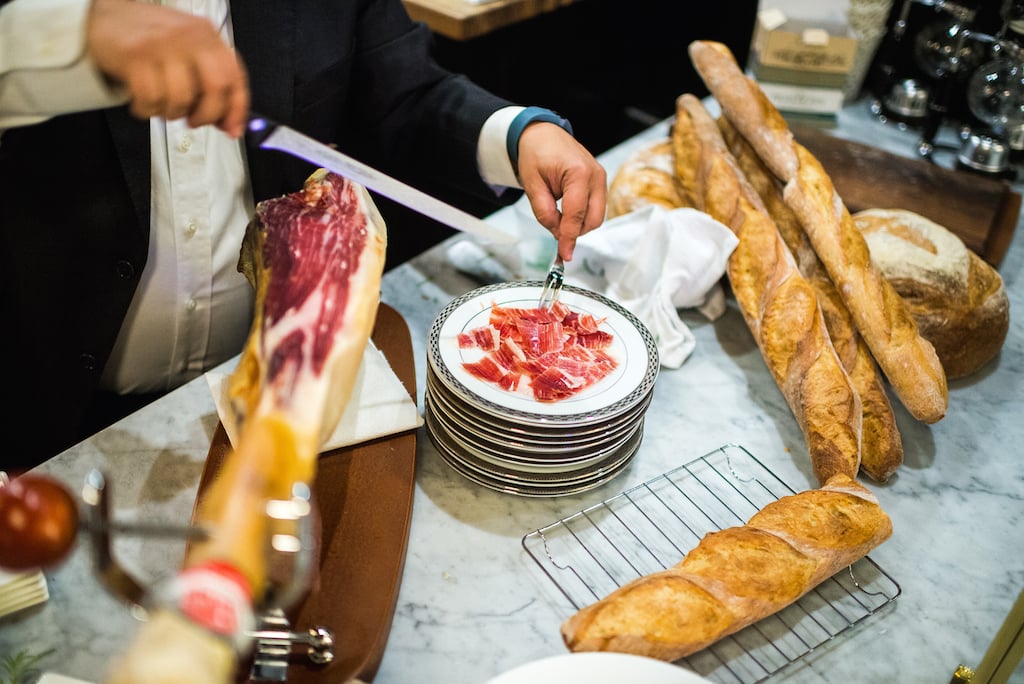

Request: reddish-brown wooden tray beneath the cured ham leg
left=197, top=304, right=417, bottom=684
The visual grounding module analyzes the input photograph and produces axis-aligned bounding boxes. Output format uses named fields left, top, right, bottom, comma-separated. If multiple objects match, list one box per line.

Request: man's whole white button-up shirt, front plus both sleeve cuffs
left=0, top=0, right=522, bottom=393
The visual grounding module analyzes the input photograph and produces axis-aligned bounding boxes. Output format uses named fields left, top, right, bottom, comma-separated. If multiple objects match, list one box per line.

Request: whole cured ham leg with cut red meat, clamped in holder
left=110, top=170, right=387, bottom=684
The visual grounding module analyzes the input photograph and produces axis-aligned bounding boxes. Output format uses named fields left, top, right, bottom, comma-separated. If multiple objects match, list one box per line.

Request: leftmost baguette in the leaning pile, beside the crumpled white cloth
left=674, top=94, right=862, bottom=484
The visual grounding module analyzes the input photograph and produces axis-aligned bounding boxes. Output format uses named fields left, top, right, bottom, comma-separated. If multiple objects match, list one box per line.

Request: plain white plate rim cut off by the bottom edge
left=485, top=652, right=711, bottom=684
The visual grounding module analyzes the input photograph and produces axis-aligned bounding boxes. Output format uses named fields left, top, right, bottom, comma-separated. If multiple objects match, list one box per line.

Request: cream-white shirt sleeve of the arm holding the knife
left=0, top=0, right=125, bottom=137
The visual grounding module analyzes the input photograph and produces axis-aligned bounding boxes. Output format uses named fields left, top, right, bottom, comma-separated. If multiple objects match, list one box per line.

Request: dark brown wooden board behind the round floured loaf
left=793, top=126, right=1021, bottom=267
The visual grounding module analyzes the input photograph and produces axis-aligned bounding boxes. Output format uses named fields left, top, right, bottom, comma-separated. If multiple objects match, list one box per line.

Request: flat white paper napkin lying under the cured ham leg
left=206, top=340, right=423, bottom=452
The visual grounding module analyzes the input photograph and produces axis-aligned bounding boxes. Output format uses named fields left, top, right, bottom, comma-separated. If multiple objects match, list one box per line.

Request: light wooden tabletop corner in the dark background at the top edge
left=404, top=0, right=574, bottom=40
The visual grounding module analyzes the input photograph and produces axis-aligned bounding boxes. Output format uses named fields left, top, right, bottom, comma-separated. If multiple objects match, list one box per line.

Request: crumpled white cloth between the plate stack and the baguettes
left=565, top=206, right=738, bottom=369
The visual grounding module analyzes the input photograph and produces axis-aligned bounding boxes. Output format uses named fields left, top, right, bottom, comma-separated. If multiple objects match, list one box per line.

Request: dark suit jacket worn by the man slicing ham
left=0, top=0, right=509, bottom=469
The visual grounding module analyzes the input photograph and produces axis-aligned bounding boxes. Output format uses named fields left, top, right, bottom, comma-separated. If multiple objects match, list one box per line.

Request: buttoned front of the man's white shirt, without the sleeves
left=100, top=0, right=254, bottom=392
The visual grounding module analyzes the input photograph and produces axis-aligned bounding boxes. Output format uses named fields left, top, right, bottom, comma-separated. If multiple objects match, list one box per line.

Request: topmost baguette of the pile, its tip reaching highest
left=689, top=41, right=949, bottom=423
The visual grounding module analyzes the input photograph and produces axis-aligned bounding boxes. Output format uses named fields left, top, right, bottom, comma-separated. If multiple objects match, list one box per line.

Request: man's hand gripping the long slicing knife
left=86, top=0, right=249, bottom=137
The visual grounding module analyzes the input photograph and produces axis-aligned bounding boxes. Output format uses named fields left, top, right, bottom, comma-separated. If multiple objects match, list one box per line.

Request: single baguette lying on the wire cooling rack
left=561, top=475, right=892, bottom=660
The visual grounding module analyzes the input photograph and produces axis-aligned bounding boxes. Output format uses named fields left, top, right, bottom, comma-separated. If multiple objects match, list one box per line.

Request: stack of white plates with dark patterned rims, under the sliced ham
left=424, top=282, right=658, bottom=497
